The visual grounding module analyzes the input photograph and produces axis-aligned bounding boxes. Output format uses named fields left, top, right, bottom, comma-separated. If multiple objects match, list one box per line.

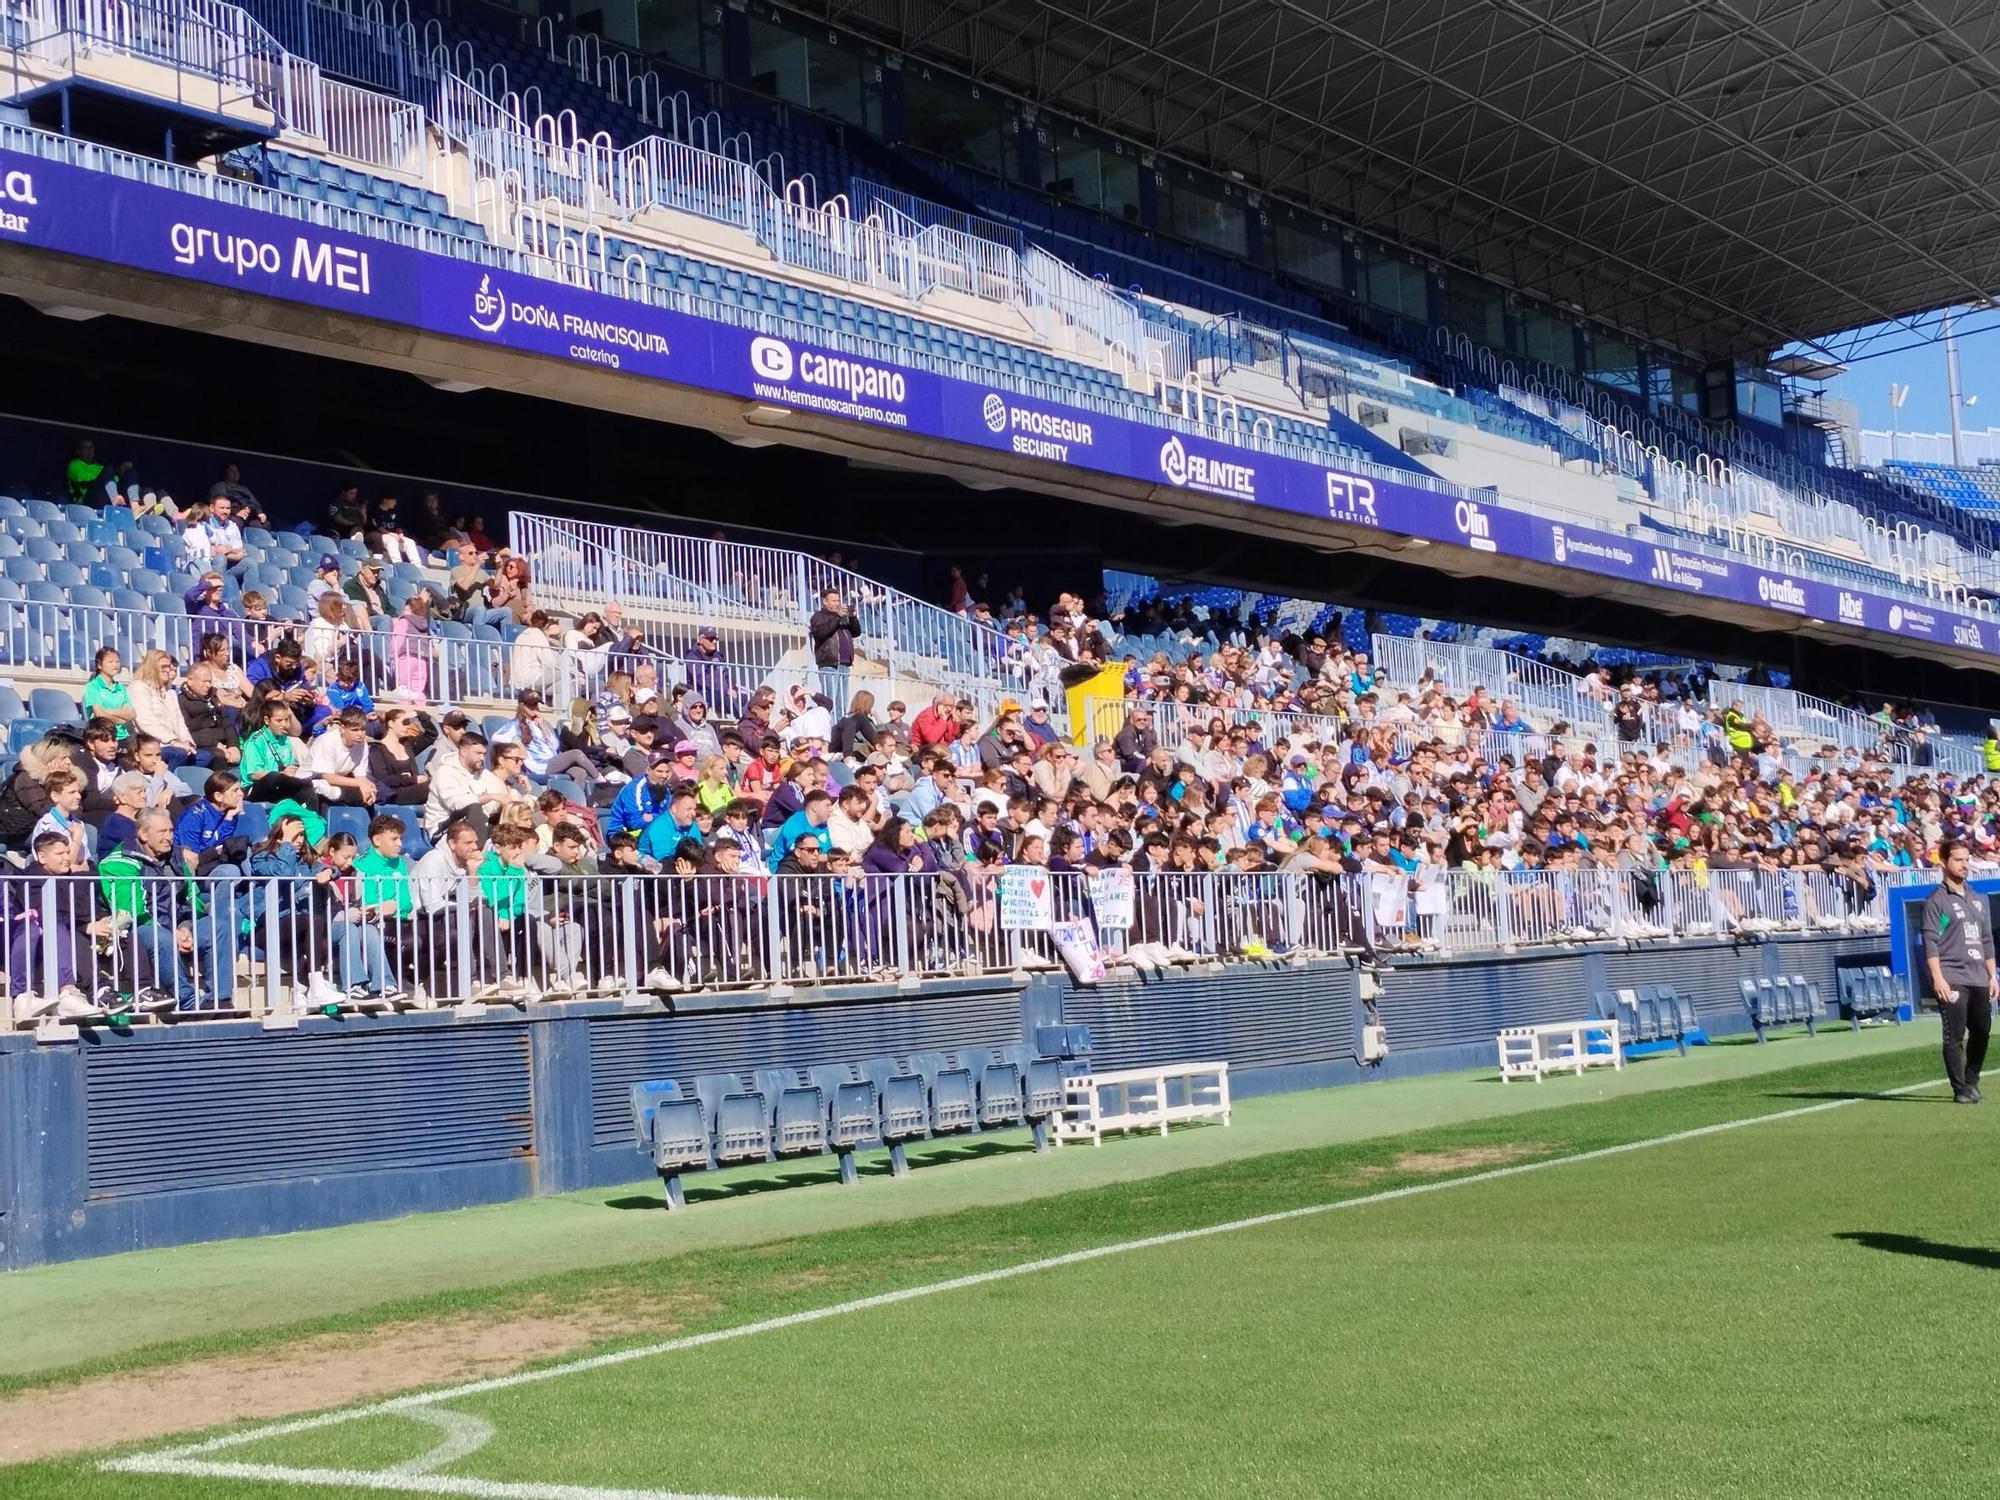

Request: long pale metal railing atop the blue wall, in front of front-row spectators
left=0, top=864, right=1888, bottom=1020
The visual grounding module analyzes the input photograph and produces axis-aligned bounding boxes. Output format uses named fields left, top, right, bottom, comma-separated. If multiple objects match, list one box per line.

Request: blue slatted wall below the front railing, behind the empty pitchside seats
left=0, top=938, right=1886, bottom=1270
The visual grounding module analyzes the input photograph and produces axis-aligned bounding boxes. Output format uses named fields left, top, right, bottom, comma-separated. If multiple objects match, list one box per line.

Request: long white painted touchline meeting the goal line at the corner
left=102, top=1078, right=1944, bottom=1500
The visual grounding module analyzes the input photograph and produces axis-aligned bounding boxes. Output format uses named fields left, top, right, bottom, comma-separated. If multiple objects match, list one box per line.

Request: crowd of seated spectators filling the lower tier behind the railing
left=0, top=448, right=1952, bottom=1020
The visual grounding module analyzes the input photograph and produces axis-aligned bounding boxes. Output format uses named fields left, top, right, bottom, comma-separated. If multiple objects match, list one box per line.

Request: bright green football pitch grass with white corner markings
left=0, top=1032, right=2000, bottom=1500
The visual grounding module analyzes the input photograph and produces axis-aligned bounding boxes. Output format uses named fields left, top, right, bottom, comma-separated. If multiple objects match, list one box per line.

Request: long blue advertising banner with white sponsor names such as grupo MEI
left=0, top=150, right=2000, bottom=654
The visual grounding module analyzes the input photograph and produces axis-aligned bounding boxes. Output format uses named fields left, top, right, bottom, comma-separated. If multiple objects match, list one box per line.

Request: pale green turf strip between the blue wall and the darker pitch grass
left=0, top=1020, right=1936, bottom=1392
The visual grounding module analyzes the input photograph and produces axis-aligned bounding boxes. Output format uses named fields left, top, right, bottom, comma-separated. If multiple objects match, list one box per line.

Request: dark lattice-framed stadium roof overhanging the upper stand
left=802, top=0, right=2000, bottom=358
